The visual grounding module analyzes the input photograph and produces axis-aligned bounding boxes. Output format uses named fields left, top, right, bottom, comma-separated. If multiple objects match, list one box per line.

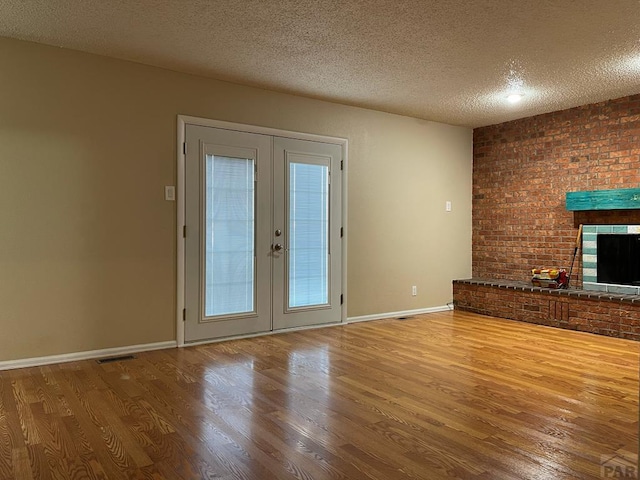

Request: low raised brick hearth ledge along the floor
left=453, top=280, right=640, bottom=341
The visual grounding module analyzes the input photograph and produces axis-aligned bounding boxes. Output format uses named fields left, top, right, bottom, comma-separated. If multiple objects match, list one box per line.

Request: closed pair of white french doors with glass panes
left=185, top=125, right=342, bottom=342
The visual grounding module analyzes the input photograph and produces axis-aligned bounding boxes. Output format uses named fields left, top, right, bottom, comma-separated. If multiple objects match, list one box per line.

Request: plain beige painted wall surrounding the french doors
left=0, top=39, right=472, bottom=361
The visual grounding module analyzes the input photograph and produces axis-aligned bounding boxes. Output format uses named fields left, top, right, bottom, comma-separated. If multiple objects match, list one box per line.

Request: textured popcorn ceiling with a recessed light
left=0, top=0, right=640, bottom=127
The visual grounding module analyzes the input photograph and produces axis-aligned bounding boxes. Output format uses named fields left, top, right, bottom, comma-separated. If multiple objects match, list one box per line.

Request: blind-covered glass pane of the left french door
left=204, top=155, right=255, bottom=317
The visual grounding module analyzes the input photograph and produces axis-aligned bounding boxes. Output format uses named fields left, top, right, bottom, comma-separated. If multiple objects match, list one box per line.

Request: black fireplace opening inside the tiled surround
left=597, top=233, right=640, bottom=286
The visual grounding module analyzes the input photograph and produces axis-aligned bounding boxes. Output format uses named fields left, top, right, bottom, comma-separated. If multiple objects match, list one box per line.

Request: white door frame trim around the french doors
left=176, top=115, right=349, bottom=347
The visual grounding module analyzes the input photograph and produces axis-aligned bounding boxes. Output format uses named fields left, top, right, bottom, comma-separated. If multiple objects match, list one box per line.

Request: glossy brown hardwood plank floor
left=0, top=312, right=640, bottom=480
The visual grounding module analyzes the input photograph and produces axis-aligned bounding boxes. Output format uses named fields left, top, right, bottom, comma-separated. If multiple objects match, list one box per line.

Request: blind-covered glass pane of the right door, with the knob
left=288, top=162, right=329, bottom=308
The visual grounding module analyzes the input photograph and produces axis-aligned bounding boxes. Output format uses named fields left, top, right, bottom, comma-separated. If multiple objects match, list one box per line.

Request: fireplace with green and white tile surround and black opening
left=582, top=225, right=640, bottom=295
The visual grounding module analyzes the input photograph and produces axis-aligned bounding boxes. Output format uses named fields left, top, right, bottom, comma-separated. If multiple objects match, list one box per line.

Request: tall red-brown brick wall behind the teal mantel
left=473, top=95, right=640, bottom=287
